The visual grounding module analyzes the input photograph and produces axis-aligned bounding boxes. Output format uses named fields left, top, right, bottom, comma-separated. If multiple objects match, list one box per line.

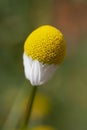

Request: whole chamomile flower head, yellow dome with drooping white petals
left=23, top=25, right=66, bottom=86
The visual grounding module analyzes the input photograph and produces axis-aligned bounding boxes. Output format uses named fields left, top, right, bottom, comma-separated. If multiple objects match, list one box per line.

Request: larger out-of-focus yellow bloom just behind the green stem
left=23, top=93, right=51, bottom=119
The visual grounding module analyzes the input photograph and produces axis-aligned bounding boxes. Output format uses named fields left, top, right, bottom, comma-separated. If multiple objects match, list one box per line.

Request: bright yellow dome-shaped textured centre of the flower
left=24, top=25, right=66, bottom=64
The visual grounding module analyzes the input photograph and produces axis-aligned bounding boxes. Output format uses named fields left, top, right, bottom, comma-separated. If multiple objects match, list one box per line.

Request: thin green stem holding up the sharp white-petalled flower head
left=22, top=86, right=37, bottom=129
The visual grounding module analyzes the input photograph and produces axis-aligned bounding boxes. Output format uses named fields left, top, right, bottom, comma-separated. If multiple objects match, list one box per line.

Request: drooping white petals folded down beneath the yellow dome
left=23, top=53, right=58, bottom=86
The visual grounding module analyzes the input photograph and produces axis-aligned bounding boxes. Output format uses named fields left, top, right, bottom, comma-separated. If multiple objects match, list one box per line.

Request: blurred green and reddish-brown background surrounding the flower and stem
left=0, top=0, right=87, bottom=130
